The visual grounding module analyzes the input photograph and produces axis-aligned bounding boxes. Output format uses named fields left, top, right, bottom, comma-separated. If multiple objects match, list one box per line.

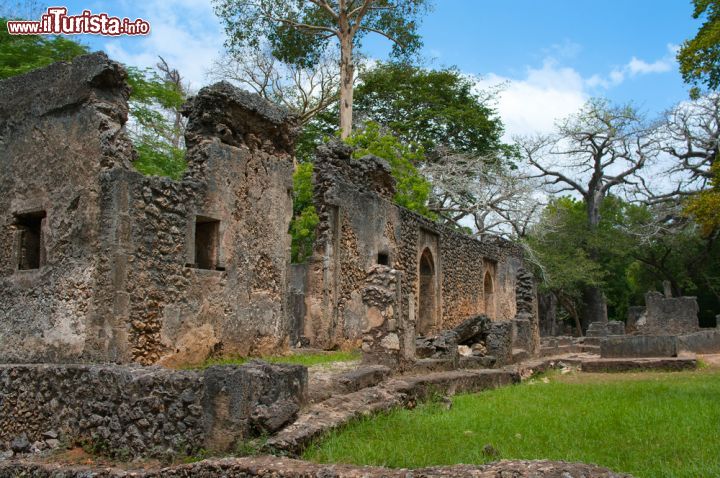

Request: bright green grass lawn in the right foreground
left=305, top=368, right=720, bottom=478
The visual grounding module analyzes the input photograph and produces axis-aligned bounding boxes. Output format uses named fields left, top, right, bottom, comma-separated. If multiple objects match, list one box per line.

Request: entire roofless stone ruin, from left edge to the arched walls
left=0, top=53, right=538, bottom=365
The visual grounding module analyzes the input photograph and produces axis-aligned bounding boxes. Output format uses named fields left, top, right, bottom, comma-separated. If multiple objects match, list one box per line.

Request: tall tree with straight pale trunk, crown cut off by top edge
left=215, top=0, right=428, bottom=139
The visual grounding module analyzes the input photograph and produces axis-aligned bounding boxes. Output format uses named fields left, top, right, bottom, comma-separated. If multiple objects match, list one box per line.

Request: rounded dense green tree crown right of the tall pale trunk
left=355, top=63, right=505, bottom=156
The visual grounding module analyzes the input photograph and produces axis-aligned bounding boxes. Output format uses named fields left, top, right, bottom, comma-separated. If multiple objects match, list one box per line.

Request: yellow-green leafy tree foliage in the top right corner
left=677, top=0, right=720, bottom=97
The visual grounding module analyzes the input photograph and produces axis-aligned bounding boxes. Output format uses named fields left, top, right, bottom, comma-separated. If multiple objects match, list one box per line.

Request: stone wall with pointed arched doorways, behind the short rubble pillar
left=304, top=143, right=537, bottom=347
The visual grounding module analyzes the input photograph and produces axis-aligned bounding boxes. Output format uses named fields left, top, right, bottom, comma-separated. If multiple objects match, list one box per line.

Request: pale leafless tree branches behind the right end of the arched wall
left=422, top=150, right=542, bottom=237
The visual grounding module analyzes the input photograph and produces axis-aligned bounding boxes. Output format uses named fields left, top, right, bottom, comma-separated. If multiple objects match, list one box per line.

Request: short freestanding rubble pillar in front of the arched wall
left=362, top=265, right=415, bottom=369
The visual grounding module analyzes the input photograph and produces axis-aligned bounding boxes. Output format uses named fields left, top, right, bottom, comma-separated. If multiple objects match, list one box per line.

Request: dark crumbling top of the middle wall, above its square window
left=183, top=81, right=297, bottom=155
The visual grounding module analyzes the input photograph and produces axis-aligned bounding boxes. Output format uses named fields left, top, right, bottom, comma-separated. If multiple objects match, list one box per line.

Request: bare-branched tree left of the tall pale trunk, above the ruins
left=208, top=48, right=340, bottom=125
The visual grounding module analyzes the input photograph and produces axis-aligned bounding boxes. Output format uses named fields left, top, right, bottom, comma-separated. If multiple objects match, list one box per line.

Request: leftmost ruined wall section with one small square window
left=0, top=56, right=133, bottom=362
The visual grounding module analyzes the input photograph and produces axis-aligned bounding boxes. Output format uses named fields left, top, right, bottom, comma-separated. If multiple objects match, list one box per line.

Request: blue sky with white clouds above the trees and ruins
left=35, top=0, right=700, bottom=135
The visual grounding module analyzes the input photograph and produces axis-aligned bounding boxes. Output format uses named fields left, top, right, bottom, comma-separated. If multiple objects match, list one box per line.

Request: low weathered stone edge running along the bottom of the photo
left=0, top=456, right=632, bottom=478
